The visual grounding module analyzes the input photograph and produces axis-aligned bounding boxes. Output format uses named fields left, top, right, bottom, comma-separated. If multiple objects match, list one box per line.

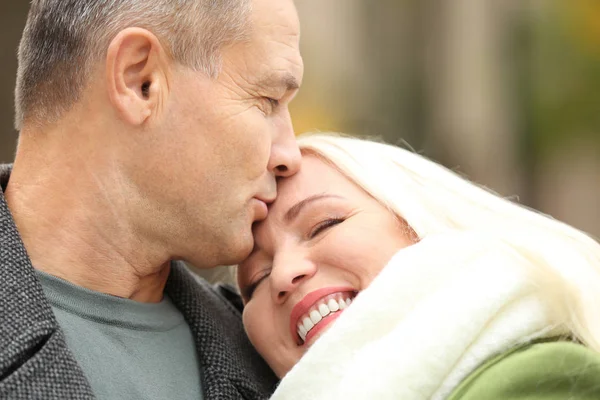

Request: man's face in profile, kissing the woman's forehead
left=146, top=0, right=303, bottom=267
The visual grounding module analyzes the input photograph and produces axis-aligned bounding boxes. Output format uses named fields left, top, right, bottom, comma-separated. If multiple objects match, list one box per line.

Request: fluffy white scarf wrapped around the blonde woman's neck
left=272, top=233, right=560, bottom=400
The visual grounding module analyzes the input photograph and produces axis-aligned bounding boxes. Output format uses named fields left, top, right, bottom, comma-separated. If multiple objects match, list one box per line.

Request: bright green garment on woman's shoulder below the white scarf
left=448, top=341, right=600, bottom=400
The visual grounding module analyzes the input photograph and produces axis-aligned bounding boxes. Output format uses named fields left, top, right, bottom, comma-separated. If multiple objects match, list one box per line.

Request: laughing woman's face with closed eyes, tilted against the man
left=238, top=155, right=414, bottom=377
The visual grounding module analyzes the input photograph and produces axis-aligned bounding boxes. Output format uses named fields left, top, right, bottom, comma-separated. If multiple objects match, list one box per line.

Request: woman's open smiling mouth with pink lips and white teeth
left=290, top=287, right=356, bottom=346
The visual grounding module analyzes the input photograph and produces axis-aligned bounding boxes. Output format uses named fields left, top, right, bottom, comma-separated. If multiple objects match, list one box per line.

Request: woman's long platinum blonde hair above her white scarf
left=298, top=133, right=600, bottom=352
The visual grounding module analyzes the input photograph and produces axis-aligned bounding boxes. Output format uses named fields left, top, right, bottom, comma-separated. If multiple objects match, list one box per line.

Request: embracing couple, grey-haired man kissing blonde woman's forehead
left=0, top=0, right=600, bottom=399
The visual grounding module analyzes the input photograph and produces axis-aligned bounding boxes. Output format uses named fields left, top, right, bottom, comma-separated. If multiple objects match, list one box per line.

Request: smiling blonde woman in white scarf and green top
left=238, top=134, right=600, bottom=400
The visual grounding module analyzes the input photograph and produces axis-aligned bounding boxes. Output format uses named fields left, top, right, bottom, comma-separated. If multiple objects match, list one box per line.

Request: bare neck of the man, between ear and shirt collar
left=5, top=135, right=170, bottom=302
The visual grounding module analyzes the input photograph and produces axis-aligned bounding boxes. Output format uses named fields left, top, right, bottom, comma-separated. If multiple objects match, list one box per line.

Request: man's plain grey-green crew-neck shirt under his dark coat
left=37, top=271, right=203, bottom=400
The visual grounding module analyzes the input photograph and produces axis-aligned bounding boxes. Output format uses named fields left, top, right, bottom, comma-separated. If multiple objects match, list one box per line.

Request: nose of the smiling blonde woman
left=271, top=256, right=317, bottom=304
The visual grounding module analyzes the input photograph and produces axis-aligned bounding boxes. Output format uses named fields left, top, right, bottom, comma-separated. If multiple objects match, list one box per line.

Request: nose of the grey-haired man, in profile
left=267, top=110, right=302, bottom=177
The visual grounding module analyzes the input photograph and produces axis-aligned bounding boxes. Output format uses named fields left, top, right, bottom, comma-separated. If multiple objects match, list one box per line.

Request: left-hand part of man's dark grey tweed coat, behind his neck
left=0, top=173, right=93, bottom=399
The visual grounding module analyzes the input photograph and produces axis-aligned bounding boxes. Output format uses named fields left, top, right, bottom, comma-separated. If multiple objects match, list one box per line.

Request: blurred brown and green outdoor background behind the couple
left=0, top=0, right=600, bottom=282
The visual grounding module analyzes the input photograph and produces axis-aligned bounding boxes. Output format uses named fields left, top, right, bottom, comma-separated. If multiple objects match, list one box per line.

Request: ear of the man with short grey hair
left=106, top=28, right=169, bottom=125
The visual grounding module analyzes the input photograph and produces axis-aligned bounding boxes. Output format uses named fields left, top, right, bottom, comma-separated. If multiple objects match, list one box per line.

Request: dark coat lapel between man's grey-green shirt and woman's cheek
left=167, top=263, right=277, bottom=399
